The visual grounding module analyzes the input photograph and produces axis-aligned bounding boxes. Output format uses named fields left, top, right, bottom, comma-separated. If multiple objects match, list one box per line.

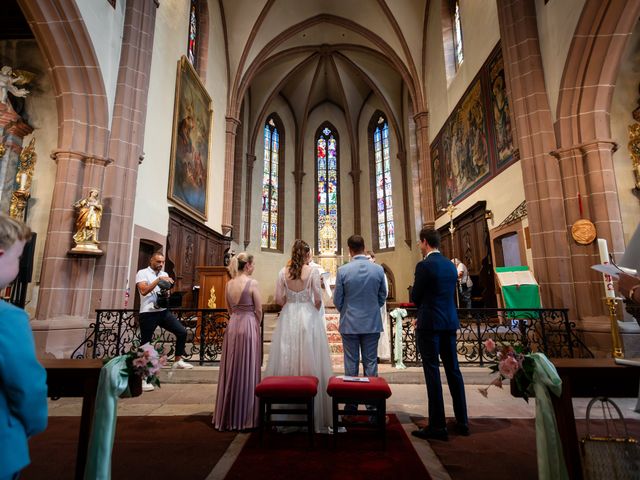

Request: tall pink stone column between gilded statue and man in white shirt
left=91, top=0, right=157, bottom=313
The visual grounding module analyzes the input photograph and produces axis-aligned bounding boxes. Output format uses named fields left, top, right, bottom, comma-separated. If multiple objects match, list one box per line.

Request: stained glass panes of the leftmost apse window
left=260, top=117, right=280, bottom=249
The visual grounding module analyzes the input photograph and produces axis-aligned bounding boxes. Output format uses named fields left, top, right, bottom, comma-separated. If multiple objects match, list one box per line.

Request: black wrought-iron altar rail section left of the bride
left=71, top=308, right=264, bottom=365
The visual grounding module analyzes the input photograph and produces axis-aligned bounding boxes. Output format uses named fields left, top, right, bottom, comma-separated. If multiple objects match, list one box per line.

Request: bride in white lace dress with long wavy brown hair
left=265, top=240, right=333, bottom=433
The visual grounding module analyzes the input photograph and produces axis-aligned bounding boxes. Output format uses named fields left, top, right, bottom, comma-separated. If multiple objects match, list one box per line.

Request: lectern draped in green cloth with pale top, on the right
left=495, top=266, right=541, bottom=318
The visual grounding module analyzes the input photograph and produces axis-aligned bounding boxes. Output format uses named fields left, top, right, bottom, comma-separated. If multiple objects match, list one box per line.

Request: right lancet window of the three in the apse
left=369, top=113, right=396, bottom=250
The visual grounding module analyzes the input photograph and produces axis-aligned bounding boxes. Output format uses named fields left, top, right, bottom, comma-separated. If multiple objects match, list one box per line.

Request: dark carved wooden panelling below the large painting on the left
left=166, top=208, right=231, bottom=307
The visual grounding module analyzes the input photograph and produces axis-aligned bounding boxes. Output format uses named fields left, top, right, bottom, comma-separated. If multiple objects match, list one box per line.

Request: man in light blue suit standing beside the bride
left=333, top=235, right=387, bottom=377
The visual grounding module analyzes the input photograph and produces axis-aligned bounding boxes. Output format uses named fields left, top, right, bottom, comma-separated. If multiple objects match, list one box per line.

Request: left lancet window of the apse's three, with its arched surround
left=260, top=113, right=284, bottom=251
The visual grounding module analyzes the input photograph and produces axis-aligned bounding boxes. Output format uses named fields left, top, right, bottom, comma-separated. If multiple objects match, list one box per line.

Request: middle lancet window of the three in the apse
left=316, top=124, right=340, bottom=254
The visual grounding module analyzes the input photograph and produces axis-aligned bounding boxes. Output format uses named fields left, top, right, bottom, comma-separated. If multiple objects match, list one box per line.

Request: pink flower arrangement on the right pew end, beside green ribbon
left=478, top=339, right=535, bottom=402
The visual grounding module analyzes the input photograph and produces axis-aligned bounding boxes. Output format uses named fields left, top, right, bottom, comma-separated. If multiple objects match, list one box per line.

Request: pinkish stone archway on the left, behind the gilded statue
left=18, top=0, right=109, bottom=320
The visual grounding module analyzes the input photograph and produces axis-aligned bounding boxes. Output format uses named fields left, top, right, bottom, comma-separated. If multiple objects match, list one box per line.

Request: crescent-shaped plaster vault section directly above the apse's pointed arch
left=238, top=0, right=402, bottom=80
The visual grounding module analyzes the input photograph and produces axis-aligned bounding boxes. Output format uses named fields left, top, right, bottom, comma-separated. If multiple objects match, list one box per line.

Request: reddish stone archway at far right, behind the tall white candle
left=554, top=0, right=640, bottom=320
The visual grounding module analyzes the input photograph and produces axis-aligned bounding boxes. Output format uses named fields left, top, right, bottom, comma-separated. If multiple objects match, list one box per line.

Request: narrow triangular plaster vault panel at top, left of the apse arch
left=221, top=0, right=267, bottom=78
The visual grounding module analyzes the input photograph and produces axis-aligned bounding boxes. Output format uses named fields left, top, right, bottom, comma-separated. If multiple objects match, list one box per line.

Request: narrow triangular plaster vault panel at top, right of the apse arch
left=386, top=0, right=429, bottom=81
